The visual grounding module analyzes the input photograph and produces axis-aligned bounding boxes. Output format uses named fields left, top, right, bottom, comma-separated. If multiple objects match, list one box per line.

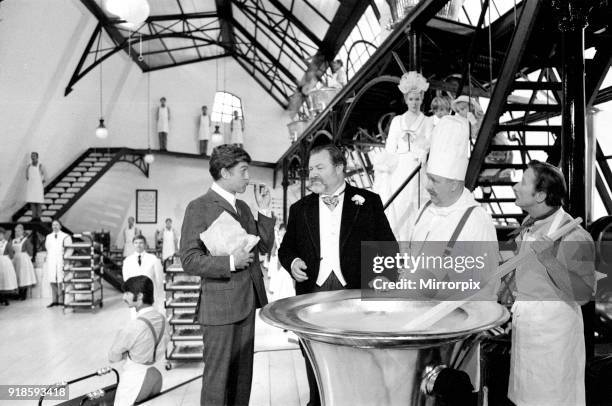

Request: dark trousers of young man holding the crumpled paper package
left=200, top=307, right=255, bottom=406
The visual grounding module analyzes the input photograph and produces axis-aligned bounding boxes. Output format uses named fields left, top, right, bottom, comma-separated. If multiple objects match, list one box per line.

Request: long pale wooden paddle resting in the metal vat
left=403, top=217, right=582, bottom=331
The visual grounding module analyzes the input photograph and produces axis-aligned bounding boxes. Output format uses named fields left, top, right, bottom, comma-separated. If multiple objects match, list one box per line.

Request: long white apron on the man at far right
left=508, top=210, right=586, bottom=406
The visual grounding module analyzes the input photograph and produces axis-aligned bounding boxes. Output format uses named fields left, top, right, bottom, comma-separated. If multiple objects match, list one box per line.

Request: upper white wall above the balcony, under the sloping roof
left=0, top=0, right=289, bottom=221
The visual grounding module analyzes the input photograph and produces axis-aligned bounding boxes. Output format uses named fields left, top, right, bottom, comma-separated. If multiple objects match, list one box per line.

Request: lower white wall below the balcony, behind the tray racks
left=61, top=155, right=280, bottom=246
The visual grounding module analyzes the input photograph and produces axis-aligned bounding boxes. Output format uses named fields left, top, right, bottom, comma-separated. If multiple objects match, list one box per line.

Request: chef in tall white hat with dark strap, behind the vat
left=409, top=112, right=499, bottom=390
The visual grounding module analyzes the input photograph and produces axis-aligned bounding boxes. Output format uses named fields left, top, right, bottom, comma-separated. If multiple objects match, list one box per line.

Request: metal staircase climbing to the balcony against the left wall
left=13, top=148, right=149, bottom=223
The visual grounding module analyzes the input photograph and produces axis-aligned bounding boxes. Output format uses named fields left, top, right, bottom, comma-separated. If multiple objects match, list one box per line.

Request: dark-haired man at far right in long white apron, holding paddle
left=508, top=161, right=595, bottom=406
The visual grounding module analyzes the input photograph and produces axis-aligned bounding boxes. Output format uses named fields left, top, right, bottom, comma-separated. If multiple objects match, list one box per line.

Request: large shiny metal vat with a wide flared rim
left=261, top=290, right=510, bottom=406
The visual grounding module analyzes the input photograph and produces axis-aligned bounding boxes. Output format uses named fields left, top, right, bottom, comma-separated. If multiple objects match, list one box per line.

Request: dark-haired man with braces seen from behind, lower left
left=108, top=275, right=168, bottom=406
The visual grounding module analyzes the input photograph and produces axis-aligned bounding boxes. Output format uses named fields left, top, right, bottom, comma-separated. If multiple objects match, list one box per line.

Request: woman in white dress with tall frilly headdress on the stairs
left=374, top=71, right=433, bottom=241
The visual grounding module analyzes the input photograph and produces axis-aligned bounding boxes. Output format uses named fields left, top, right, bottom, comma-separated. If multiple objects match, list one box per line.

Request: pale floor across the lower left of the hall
left=0, top=287, right=308, bottom=406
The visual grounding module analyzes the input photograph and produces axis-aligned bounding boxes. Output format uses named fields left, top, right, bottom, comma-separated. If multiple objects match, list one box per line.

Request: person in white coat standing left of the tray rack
left=44, top=220, right=73, bottom=307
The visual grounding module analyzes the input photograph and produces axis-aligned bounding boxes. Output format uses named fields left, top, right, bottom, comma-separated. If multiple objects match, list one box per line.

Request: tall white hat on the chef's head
left=427, top=116, right=470, bottom=181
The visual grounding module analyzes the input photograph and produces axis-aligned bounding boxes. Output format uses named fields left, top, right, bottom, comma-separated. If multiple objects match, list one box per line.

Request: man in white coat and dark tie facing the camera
left=122, top=235, right=165, bottom=316
